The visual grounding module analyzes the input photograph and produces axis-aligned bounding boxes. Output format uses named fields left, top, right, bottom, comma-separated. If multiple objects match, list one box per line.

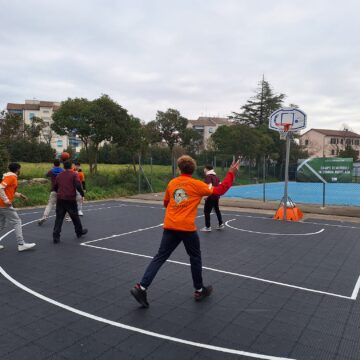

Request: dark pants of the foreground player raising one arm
left=140, top=230, right=203, bottom=289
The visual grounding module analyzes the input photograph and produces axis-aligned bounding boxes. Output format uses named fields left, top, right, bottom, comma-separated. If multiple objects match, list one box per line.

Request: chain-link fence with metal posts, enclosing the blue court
left=136, top=155, right=360, bottom=207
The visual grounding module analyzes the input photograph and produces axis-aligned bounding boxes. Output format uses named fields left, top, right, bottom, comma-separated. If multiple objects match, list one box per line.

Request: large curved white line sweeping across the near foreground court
left=0, top=266, right=294, bottom=360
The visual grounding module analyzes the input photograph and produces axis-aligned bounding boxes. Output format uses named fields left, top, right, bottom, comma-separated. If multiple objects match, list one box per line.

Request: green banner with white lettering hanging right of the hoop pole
left=296, top=158, right=353, bottom=183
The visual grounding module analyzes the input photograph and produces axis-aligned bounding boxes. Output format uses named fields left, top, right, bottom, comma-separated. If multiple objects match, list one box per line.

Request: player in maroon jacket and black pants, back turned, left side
left=53, top=161, right=88, bottom=244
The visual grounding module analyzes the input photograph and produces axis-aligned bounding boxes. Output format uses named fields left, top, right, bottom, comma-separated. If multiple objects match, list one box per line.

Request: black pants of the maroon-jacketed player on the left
left=53, top=199, right=83, bottom=239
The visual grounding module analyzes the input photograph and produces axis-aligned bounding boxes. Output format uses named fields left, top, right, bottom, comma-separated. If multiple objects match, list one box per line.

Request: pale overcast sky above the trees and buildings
left=0, top=0, right=360, bottom=133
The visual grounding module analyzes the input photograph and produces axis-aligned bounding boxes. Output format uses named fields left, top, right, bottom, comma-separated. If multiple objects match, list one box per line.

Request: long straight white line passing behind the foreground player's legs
left=80, top=243, right=352, bottom=300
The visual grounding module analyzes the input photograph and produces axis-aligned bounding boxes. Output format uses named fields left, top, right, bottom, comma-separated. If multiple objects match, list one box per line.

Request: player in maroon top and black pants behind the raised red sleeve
left=200, top=165, right=224, bottom=232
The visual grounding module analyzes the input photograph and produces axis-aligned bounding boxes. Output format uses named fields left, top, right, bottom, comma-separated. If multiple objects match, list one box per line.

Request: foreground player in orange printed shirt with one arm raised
left=130, top=155, right=239, bottom=307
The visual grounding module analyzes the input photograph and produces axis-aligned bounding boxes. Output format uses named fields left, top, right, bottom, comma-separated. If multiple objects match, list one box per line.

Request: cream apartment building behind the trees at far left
left=6, top=100, right=81, bottom=154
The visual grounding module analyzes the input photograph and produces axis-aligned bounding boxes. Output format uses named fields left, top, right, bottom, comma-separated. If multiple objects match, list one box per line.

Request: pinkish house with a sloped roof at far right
left=300, top=129, right=360, bottom=157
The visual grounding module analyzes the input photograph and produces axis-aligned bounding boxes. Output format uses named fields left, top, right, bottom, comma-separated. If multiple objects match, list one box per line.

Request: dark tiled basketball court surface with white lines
left=0, top=201, right=360, bottom=360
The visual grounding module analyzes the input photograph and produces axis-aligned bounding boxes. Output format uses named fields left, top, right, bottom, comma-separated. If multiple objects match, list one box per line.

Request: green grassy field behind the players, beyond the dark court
left=16, top=163, right=251, bottom=207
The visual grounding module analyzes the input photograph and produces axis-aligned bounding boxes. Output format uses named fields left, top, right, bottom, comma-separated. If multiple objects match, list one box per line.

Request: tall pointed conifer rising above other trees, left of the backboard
left=230, top=77, right=285, bottom=127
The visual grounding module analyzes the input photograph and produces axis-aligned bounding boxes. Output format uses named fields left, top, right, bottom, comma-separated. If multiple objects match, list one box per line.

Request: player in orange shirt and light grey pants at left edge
left=0, top=163, right=36, bottom=251
